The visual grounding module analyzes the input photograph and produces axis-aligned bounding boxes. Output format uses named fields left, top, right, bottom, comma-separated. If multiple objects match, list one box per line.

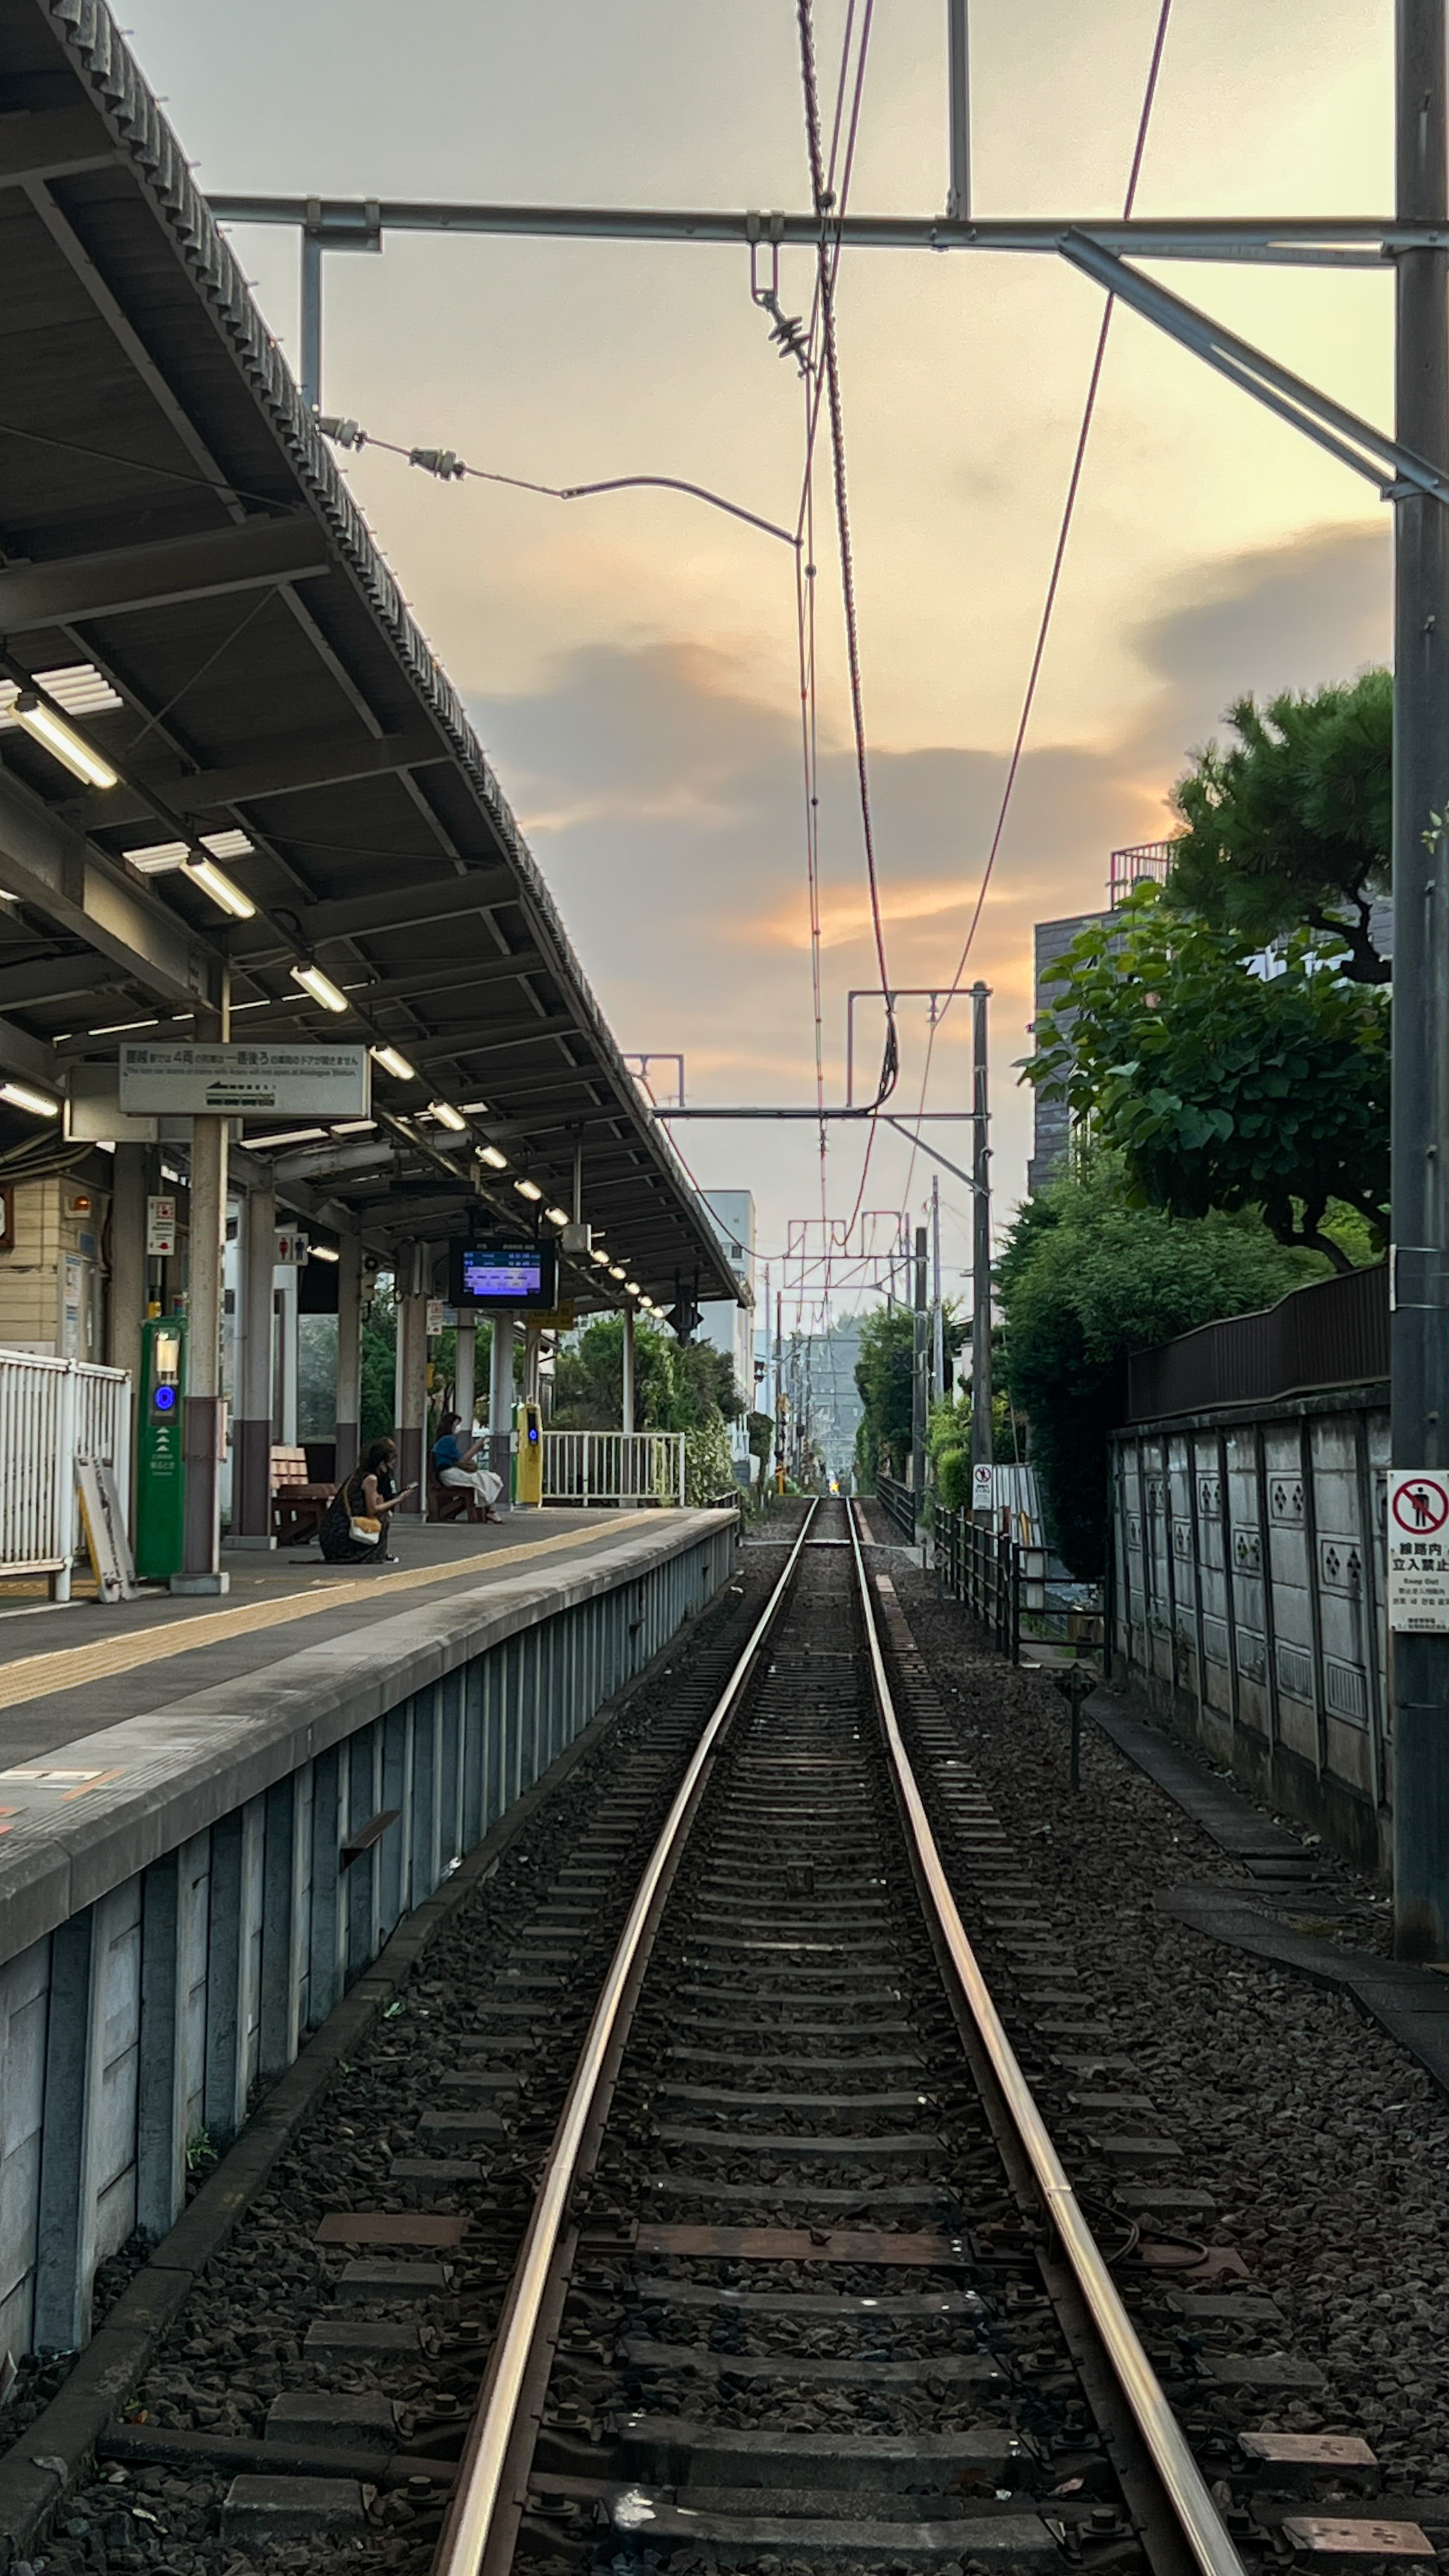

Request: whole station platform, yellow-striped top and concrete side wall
left=0, top=1507, right=738, bottom=2352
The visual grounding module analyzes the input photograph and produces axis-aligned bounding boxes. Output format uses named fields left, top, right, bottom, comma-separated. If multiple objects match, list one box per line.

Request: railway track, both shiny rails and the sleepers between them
left=435, top=1504, right=1261, bottom=2576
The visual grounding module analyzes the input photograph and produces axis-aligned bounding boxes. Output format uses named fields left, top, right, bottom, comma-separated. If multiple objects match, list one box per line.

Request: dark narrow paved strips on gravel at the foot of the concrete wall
left=1083, top=1690, right=1449, bottom=2095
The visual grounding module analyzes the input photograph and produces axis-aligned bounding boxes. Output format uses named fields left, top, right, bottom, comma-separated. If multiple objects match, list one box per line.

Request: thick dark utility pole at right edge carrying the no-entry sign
left=1390, top=0, right=1449, bottom=1958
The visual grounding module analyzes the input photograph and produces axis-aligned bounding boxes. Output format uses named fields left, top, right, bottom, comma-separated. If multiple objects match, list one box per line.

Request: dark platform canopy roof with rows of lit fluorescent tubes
left=0, top=0, right=738, bottom=1303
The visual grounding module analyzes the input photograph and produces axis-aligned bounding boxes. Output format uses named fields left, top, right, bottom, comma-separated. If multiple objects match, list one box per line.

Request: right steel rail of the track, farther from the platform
left=846, top=1502, right=1246, bottom=2576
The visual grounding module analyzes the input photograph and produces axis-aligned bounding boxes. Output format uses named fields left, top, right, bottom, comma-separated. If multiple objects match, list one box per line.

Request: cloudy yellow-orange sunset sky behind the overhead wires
left=126, top=0, right=1392, bottom=1303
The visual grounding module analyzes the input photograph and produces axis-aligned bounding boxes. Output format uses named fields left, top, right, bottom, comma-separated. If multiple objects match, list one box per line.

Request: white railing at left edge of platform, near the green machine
left=0, top=1350, right=131, bottom=1600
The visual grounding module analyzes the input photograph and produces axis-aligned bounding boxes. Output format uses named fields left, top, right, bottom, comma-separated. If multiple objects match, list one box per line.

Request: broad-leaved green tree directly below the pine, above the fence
left=1024, top=886, right=1390, bottom=1270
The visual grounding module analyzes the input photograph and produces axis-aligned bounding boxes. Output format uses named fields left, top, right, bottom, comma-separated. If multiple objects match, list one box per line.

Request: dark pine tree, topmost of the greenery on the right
left=1166, top=670, right=1392, bottom=984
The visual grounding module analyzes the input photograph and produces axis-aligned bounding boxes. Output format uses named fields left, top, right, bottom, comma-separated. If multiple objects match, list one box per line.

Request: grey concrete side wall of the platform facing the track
left=0, top=1512, right=736, bottom=2355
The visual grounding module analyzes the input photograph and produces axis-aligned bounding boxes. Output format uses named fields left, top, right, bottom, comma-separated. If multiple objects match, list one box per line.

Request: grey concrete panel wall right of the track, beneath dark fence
left=1112, top=1386, right=1390, bottom=1870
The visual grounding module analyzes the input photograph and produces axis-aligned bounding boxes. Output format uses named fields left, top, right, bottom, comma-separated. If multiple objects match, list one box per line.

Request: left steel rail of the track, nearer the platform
left=433, top=1502, right=819, bottom=2576
